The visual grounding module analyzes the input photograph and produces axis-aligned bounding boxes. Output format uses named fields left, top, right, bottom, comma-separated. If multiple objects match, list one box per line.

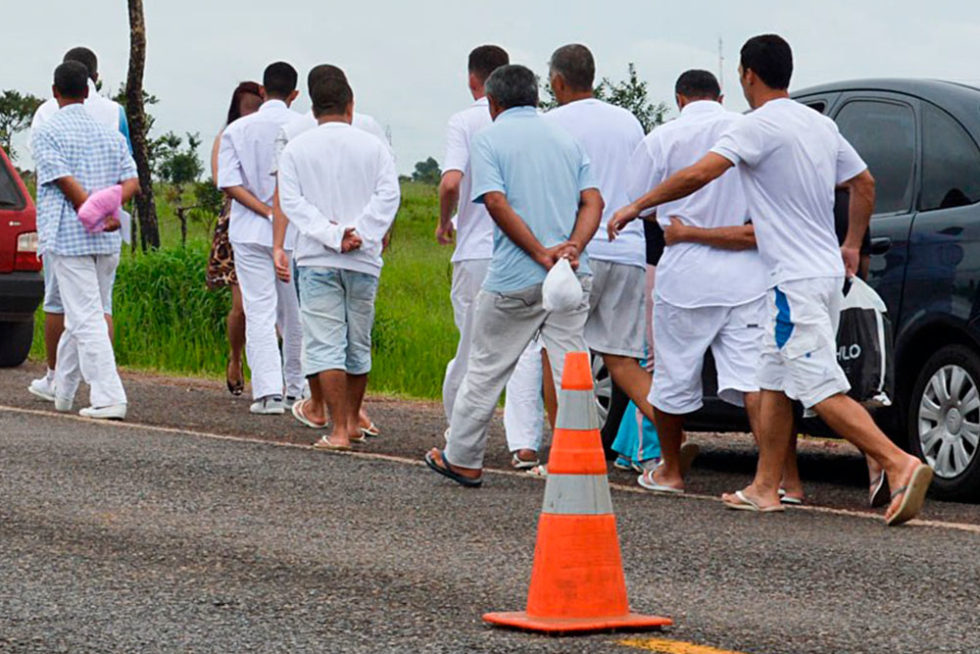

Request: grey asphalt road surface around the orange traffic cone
left=0, top=370, right=980, bottom=653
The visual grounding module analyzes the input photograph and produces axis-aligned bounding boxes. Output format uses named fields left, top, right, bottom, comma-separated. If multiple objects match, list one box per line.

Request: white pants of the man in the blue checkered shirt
left=50, top=254, right=126, bottom=408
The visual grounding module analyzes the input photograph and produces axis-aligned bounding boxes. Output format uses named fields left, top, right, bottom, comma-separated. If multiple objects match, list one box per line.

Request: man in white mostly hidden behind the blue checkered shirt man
left=28, top=47, right=133, bottom=401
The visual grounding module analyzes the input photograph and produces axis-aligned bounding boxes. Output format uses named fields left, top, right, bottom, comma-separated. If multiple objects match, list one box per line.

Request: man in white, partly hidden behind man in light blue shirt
left=436, top=45, right=544, bottom=469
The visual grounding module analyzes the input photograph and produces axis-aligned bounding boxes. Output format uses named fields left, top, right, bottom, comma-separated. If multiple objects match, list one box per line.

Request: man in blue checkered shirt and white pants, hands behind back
left=31, top=61, right=139, bottom=420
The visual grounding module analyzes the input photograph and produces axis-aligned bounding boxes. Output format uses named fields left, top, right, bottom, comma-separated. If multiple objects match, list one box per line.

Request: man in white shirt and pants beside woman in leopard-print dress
left=218, top=61, right=303, bottom=415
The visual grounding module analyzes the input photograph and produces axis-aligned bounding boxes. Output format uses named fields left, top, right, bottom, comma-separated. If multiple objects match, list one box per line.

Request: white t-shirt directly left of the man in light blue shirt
left=442, top=98, right=493, bottom=263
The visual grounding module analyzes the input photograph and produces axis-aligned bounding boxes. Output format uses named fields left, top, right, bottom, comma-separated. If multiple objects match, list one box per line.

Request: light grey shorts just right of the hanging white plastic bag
left=585, top=259, right=646, bottom=359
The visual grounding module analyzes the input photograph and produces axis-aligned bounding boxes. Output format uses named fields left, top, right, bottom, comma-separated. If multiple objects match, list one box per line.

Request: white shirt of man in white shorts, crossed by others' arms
left=629, top=100, right=768, bottom=308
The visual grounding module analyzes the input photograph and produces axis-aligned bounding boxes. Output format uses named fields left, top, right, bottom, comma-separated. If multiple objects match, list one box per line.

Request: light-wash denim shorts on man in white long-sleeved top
left=298, top=266, right=378, bottom=377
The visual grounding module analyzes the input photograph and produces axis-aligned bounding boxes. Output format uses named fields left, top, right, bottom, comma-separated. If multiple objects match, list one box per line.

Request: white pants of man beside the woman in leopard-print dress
left=232, top=243, right=304, bottom=399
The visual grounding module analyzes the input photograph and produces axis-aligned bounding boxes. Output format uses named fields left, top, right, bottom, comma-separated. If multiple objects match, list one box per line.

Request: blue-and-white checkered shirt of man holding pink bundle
left=31, top=104, right=136, bottom=256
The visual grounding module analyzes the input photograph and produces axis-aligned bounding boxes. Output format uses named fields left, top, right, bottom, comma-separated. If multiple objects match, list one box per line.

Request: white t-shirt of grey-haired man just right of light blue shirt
left=544, top=98, right=649, bottom=268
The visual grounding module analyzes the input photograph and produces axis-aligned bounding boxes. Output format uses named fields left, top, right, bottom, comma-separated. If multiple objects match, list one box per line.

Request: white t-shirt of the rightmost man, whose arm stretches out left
left=711, top=98, right=868, bottom=287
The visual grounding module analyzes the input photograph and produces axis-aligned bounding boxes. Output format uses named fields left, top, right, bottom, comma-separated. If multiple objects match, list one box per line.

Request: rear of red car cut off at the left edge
left=0, top=149, right=44, bottom=366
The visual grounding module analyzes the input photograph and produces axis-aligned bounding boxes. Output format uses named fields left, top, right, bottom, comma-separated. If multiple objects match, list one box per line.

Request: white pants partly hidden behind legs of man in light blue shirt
left=442, top=259, right=544, bottom=452
